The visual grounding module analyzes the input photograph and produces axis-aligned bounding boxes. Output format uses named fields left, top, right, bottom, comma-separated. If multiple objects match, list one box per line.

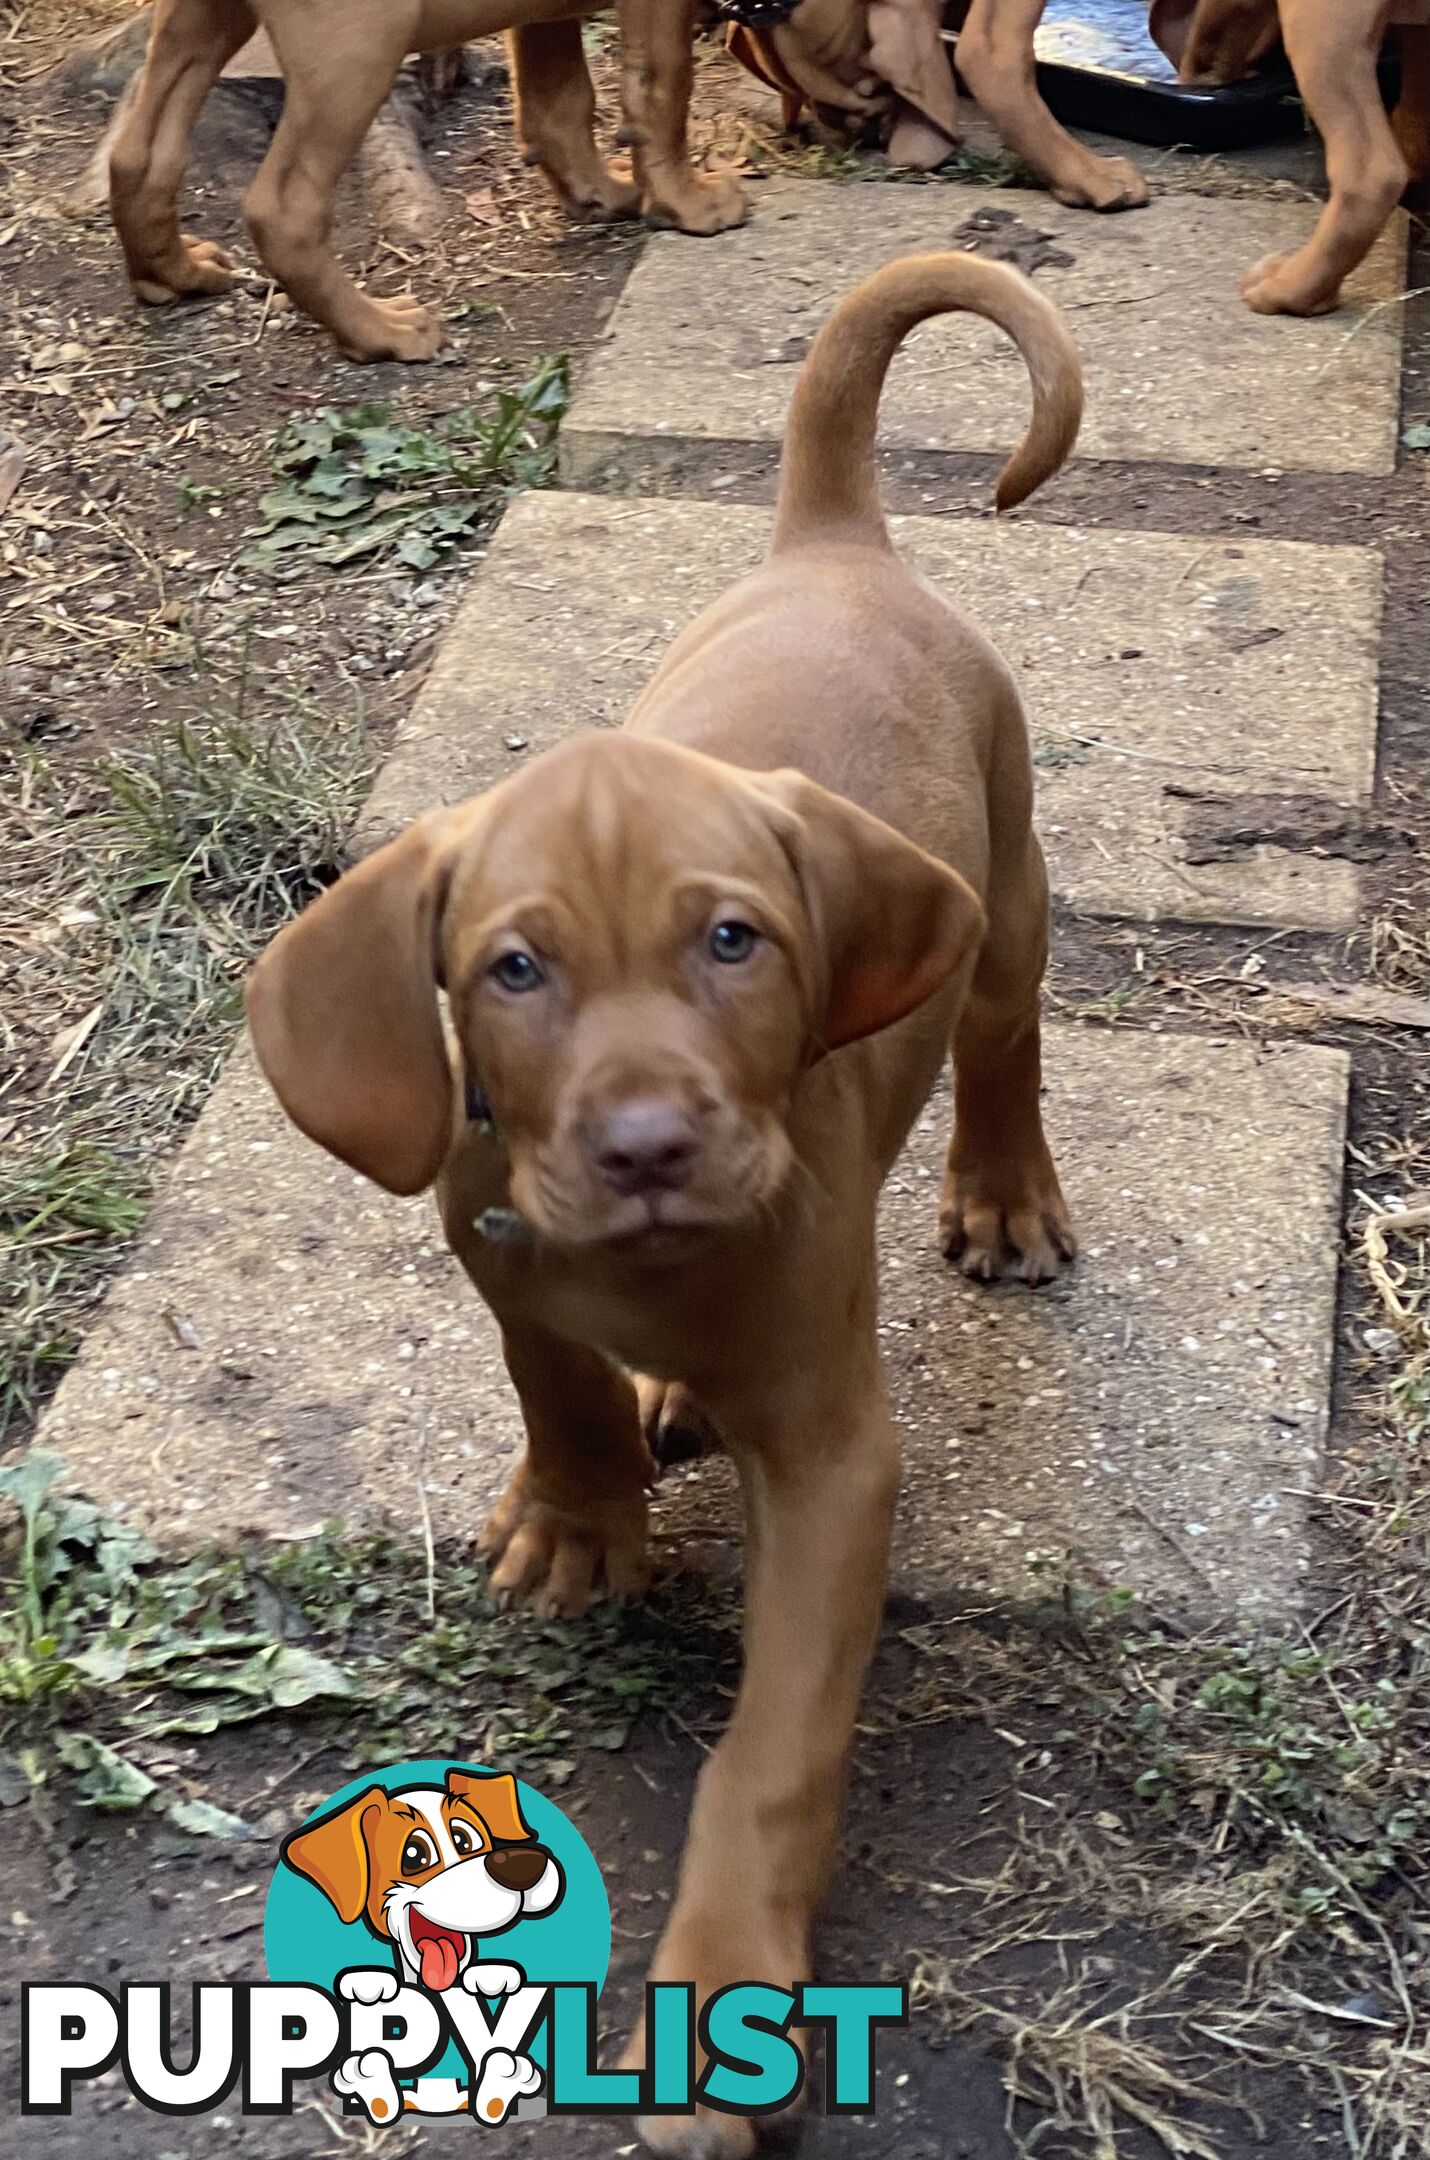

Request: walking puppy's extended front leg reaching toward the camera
left=631, top=1347, right=899, bottom=2160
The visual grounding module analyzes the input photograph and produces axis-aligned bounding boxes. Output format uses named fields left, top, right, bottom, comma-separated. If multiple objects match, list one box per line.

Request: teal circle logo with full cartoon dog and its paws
left=264, top=1758, right=611, bottom=2123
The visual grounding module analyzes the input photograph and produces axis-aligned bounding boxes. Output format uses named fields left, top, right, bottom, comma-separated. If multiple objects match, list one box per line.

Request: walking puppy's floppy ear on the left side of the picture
left=246, top=812, right=451, bottom=1192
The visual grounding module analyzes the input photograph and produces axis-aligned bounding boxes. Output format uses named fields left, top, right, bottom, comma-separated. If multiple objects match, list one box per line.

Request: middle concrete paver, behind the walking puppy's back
left=365, top=495, right=1380, bottom=929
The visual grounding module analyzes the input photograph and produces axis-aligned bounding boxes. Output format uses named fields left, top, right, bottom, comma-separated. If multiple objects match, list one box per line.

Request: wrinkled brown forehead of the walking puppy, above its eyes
left=443, top=732, right=799, bottom=981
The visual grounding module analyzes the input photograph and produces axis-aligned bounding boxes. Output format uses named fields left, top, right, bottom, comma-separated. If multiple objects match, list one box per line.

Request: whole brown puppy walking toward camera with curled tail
left=248, top=255, right=1082, bottom=2154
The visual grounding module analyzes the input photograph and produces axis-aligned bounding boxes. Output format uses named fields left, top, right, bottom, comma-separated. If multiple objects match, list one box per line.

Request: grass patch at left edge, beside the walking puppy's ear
left=0, top=654, right=372, bottom=1443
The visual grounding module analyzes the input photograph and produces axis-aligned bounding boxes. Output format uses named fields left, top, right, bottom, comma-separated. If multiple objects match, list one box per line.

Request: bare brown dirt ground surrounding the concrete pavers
left=0, top=13, right=1430, bottom=2160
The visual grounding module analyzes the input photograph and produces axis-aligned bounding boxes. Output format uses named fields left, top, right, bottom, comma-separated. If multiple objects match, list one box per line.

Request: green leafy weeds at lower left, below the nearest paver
left=0, top=1449, right=739, bottom=1836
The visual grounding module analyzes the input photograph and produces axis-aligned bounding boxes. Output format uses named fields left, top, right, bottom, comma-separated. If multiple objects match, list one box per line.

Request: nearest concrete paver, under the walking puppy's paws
left=43, top=1028, right=1346, bottom=1618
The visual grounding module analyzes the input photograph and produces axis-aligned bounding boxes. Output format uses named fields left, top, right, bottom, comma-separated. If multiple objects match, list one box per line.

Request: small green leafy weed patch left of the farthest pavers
left=240, top=356, right=570, bottom=579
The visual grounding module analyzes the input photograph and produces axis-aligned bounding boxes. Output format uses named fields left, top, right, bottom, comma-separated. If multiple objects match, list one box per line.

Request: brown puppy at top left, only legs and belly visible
left=110, top=0, right=745, bottom=361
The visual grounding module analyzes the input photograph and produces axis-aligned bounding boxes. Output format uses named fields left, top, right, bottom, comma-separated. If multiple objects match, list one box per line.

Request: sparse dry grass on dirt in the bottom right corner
left=883, top=1192, right=1430, bottom=2160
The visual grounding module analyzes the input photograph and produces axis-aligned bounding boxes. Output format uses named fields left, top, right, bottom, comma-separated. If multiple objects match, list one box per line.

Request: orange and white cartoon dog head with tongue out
left=283, top=1769, right=566, bottom=1996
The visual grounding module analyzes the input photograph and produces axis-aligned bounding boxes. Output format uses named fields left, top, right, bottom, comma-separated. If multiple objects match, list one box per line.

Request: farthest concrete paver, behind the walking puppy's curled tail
left=562, top=179, right=1406, bottom=488
